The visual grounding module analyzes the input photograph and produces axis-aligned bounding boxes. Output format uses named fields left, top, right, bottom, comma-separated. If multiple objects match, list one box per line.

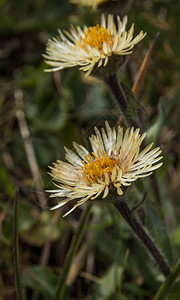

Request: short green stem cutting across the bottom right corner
left=153, top=261, right=180, bottom=300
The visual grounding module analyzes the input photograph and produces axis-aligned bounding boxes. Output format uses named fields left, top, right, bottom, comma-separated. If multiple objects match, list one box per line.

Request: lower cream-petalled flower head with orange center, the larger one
left=49, top=122, right=162, bottom=215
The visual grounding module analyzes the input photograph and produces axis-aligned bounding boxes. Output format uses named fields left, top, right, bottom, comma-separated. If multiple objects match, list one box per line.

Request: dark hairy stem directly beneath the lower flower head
left=114, top=200, right=170, bottom=277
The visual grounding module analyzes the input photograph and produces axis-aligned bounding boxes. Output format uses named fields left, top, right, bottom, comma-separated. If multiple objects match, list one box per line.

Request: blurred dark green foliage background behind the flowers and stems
left=0, top=0, right=180, bottom=300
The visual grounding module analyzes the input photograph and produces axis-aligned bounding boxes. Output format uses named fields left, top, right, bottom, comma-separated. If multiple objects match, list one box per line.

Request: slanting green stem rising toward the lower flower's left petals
left=54, top=203, right=91, bottom=300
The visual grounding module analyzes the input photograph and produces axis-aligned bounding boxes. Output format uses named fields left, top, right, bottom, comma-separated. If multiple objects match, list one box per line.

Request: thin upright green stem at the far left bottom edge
left=13, top=190, right=24, bottom=300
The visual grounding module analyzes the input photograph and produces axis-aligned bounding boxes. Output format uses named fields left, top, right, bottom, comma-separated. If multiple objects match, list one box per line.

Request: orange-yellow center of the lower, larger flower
left=82, top=152, right=118, bottom=183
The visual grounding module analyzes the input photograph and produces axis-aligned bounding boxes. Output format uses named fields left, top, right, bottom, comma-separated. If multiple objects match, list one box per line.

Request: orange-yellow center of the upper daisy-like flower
left=80, top=24, right=113, bottom=52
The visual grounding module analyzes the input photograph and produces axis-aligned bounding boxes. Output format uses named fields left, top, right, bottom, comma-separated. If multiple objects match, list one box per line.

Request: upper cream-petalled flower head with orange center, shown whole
left=44, top=14, right=146, bottom=76
